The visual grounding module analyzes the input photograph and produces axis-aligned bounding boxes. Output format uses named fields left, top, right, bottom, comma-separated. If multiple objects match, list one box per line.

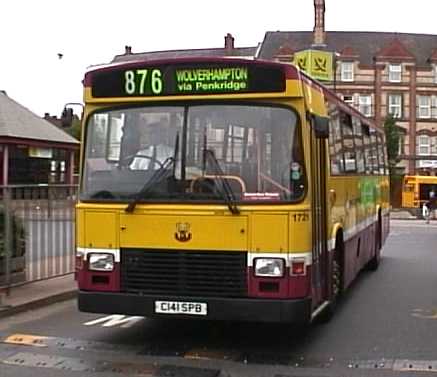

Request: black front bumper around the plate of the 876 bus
left=78, top=291, right=311, bottom=324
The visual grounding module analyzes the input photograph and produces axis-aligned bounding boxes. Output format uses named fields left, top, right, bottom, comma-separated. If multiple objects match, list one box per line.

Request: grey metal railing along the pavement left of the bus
left=0, top=185, right=77, bottom=287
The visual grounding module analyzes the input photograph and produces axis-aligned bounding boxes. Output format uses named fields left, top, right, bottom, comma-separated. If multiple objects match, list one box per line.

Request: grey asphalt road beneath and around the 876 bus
left=0, top=220, right=437, bottom=377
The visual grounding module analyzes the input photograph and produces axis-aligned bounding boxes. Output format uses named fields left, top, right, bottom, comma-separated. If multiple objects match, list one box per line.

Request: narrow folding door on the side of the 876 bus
left=311, top=122, right=329, bottom=309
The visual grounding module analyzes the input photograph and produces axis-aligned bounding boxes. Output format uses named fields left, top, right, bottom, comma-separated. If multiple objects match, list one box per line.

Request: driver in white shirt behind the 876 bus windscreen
left=130, top=122, right=174, bottom=170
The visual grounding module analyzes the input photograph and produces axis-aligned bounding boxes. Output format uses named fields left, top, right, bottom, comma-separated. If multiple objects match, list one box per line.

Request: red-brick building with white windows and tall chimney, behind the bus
left=256, top=0, right=437, bottom=175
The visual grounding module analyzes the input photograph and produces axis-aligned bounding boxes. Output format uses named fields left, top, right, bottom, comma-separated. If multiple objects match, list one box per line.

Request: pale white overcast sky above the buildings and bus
left=0, top=0, right=437, bottom=116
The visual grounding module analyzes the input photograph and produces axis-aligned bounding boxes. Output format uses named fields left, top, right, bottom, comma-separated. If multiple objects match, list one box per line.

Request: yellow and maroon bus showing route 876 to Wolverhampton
left=76, top=58, right=389, bottom=324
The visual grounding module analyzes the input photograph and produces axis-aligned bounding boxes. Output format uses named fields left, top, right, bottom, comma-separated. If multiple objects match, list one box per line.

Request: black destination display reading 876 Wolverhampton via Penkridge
left=91, top=62, right=285, bottom=97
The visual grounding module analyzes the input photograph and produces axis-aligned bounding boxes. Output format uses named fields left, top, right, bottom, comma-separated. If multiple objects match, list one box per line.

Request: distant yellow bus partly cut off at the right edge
left=402, top=175, right=437, bottom=212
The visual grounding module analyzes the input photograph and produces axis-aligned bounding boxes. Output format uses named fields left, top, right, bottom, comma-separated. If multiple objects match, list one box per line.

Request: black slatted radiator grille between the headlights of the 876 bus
left=121, top=249, right=247, bottom=297
